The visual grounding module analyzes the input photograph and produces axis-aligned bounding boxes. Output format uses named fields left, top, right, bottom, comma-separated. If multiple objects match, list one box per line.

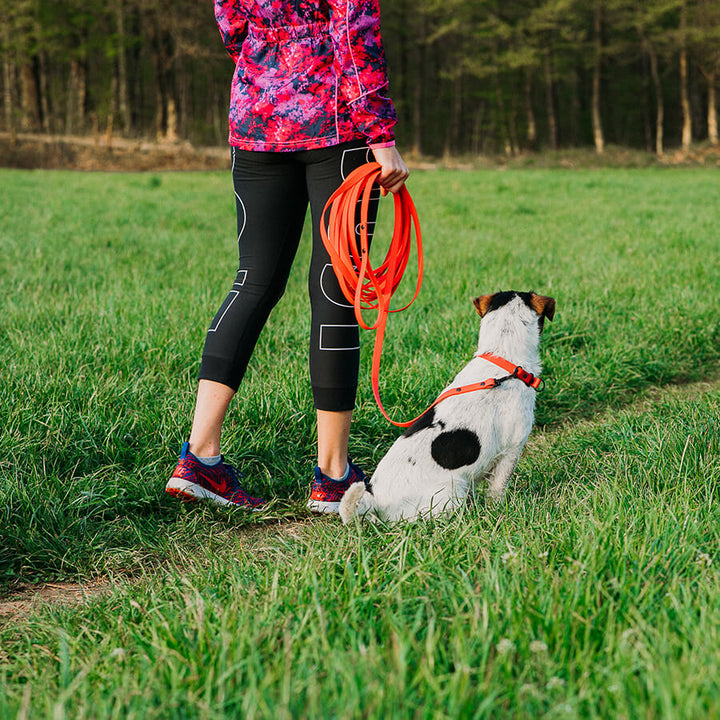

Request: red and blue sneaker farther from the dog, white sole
left=165, top=443, right=266, bottom=510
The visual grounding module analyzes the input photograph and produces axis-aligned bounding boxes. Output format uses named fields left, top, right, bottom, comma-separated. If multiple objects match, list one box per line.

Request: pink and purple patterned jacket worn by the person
left=214, top=0, right=396, bottom=151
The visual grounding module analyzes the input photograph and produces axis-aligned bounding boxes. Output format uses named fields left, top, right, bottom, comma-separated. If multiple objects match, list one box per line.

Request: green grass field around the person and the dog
left=0, top=169, right=720, bottom=720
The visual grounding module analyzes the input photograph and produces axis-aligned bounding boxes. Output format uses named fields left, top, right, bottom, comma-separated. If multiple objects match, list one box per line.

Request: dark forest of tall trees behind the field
left=0, top=0, right=720, bottom=156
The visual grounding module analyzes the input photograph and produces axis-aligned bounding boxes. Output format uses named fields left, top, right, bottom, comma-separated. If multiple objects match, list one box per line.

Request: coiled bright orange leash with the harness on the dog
left=320, top=163, right=542, bottom=427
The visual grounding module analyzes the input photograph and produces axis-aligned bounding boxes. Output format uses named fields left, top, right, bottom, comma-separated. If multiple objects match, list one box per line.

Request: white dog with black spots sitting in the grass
left=340, top=291, right=555, bottom=523
